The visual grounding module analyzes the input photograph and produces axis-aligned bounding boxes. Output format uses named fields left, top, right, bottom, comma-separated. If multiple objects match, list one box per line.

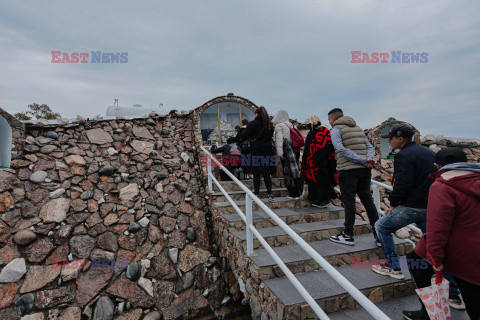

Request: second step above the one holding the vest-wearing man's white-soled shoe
left=222, top=204, right=345, bottom=232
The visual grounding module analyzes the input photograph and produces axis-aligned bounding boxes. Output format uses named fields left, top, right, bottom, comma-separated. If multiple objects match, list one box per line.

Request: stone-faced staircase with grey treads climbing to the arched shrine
left=211, top=178, right=419, bottom=320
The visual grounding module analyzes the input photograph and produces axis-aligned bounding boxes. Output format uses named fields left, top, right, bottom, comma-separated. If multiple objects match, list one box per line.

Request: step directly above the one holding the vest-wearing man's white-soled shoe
left=232, top=219, right=371, bottom=249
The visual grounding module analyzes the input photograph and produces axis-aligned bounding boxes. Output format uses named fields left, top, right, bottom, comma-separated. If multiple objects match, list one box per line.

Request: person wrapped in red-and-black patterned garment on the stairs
left=301, top=116, right=338, bottom=207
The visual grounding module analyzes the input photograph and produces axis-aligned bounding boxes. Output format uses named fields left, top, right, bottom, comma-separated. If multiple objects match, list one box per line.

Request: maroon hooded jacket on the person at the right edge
left=415, top=170, right=480, bottom=286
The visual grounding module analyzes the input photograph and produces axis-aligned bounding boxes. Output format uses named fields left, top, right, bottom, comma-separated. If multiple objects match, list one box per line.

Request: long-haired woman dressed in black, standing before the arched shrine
left=242, top=106, right=277, bottom=202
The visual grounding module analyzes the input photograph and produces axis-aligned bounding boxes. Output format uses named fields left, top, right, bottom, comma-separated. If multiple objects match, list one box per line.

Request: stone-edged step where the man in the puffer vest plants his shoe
left=250, top=234, right=412, bottom=280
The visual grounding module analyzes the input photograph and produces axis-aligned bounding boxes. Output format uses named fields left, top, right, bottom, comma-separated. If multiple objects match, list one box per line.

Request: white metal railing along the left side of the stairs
left=201, top=146, right=390, bottom=320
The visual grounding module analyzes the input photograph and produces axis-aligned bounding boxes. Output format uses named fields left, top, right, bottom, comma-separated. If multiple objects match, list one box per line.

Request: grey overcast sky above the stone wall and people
left=0, top=0, right=480, bottom=137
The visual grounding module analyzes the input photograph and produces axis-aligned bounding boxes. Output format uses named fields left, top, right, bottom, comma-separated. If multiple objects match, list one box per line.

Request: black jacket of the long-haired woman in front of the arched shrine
left=242, top=116, right=276, bottom=175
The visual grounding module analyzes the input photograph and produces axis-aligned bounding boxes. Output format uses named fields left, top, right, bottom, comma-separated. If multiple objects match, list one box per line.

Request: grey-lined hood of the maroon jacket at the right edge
left=431, top=162, right=480, bottom=200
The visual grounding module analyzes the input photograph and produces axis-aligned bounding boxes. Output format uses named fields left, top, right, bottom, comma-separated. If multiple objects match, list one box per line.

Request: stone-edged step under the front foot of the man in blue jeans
left=263, top=266, right=415, bottom=320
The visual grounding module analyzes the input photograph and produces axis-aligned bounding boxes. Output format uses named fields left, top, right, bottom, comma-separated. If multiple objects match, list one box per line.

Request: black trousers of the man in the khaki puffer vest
left=338, top=168, right=378, bottom=236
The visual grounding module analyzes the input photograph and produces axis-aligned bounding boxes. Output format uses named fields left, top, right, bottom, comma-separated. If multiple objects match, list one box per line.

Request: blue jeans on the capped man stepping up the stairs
left=375, top=206, right=427, bottom=270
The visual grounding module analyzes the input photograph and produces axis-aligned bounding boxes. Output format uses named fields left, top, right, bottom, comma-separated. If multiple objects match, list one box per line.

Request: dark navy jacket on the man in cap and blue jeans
left=388, top=141, right=437, bottom=209
